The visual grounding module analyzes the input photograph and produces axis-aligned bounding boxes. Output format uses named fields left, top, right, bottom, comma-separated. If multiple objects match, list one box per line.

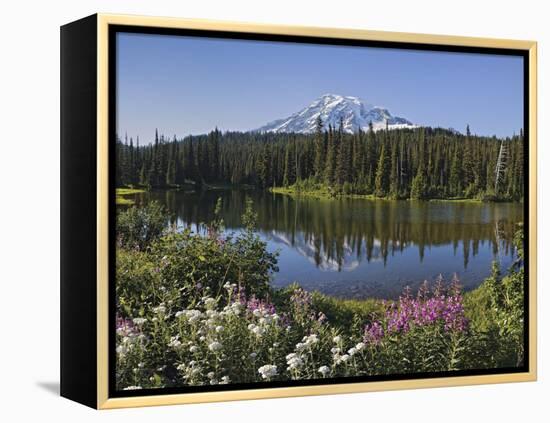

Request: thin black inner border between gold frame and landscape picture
left=107, top=24, right=531, bottom=398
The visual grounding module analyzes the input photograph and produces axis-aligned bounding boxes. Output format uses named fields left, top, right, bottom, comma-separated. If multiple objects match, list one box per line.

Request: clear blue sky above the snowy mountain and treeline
left=117, top=33, right=523, bottom=143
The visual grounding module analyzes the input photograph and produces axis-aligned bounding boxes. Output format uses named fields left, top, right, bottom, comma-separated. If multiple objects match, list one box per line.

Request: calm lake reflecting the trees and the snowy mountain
left=126, top=190, right=523, bottom=298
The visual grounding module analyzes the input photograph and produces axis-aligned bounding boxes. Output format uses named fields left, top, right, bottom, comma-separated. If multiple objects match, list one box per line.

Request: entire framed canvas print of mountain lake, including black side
left=61, top=15, right=536, bottom=408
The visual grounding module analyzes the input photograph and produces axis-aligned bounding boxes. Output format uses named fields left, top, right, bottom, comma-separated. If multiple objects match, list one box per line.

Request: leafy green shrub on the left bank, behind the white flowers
left=116, top=199, right=277, bottom=317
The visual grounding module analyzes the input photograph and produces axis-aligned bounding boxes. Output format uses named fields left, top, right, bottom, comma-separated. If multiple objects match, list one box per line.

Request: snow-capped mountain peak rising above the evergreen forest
left=257, top=94, right=417, bottom=133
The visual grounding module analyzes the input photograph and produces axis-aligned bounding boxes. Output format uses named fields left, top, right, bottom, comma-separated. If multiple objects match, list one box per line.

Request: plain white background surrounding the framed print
left=0, top=0, right=550, bottom=423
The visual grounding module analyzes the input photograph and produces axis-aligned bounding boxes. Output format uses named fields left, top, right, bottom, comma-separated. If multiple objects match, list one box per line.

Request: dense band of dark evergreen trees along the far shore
left=116, top=120, right=525, bottom=201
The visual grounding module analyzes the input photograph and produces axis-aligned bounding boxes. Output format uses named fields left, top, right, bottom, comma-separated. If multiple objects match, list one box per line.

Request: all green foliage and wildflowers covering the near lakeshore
left=116, top=202, right=523, bottom=389
